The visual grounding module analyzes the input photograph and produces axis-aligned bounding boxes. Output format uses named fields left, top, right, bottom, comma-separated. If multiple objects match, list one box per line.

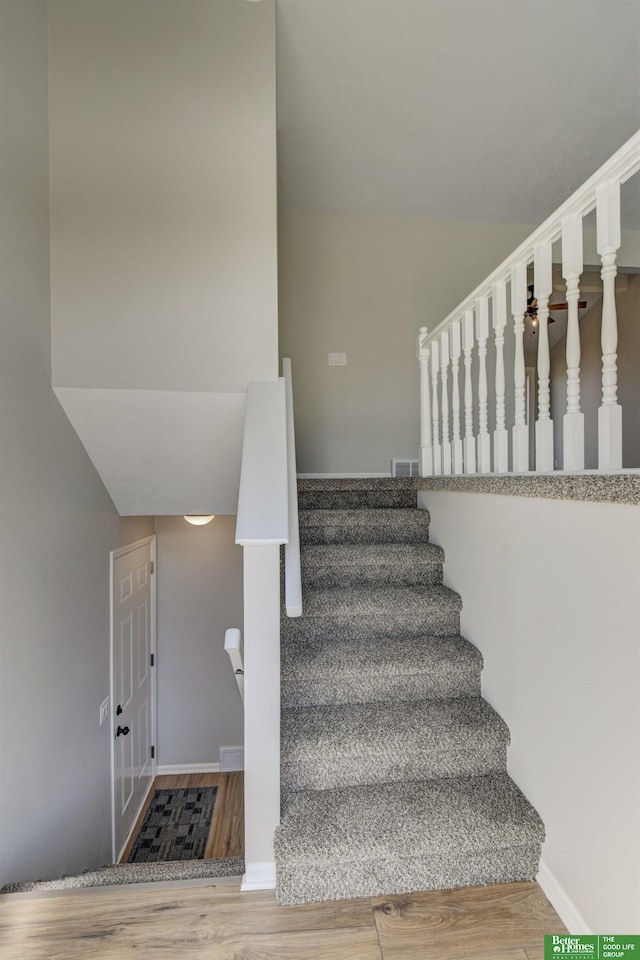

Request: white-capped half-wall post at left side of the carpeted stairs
left=236, top=380, right=289, bottom=890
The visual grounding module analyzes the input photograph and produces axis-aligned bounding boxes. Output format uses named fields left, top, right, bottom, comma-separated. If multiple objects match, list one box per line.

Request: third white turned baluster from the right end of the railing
left=533, top=240, right=553, bottom=473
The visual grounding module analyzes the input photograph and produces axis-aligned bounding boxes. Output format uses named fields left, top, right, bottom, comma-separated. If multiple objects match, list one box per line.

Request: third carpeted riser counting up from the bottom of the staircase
left=282, top=667, right=480, bottom=708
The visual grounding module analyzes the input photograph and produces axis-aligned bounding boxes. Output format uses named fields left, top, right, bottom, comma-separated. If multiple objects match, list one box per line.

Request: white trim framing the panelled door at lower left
left=109, top=533, right=158, bottom=863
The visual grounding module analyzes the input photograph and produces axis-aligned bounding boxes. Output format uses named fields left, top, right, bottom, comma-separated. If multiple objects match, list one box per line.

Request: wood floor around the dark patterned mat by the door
left=119, top=773, right=244, bottom=864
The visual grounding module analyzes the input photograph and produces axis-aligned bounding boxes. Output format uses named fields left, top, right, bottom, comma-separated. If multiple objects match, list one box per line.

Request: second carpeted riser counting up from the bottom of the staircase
left=281, top=737, right=507, bottom=796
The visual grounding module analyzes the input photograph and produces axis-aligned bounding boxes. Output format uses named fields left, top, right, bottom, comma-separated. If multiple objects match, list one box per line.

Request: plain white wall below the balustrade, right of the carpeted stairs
left=420, top=491, right=640, bottom=933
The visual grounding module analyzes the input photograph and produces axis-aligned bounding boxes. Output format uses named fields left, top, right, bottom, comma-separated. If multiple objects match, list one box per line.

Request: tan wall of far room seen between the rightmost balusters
left=551, top=274, right=640, bottom=468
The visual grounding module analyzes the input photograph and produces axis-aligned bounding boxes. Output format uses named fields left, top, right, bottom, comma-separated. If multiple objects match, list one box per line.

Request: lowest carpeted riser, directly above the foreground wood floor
left=277, top=844, right=540, bottom=909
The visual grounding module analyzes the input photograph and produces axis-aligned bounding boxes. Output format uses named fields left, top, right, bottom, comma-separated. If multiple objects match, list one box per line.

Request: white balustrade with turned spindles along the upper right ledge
left=418, top=131, right=640, bottom=477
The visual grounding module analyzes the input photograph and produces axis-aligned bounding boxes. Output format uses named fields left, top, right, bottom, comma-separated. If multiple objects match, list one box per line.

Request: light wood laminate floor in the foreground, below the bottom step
left=0, top=882, right=566, bottom=960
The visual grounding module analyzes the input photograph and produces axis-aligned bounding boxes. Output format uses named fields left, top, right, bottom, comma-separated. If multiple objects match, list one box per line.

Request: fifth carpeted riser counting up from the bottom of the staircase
left=302, top=561, right=442, bottom=588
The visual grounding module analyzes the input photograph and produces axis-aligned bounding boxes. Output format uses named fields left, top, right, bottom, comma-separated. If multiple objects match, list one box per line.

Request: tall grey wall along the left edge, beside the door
left=0, top=0, right=153, bottom=884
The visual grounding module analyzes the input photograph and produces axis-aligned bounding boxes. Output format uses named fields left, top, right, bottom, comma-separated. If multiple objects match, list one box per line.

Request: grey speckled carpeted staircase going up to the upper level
left=275, top=479, right=544, bottom=904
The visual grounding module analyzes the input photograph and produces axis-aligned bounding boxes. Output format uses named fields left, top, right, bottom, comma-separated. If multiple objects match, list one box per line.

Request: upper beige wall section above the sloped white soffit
left=49, top=0, right=277, bottom=393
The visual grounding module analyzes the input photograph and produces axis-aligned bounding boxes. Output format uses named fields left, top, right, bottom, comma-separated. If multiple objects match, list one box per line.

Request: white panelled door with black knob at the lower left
left=111, top=537, right=155, bottom=861
